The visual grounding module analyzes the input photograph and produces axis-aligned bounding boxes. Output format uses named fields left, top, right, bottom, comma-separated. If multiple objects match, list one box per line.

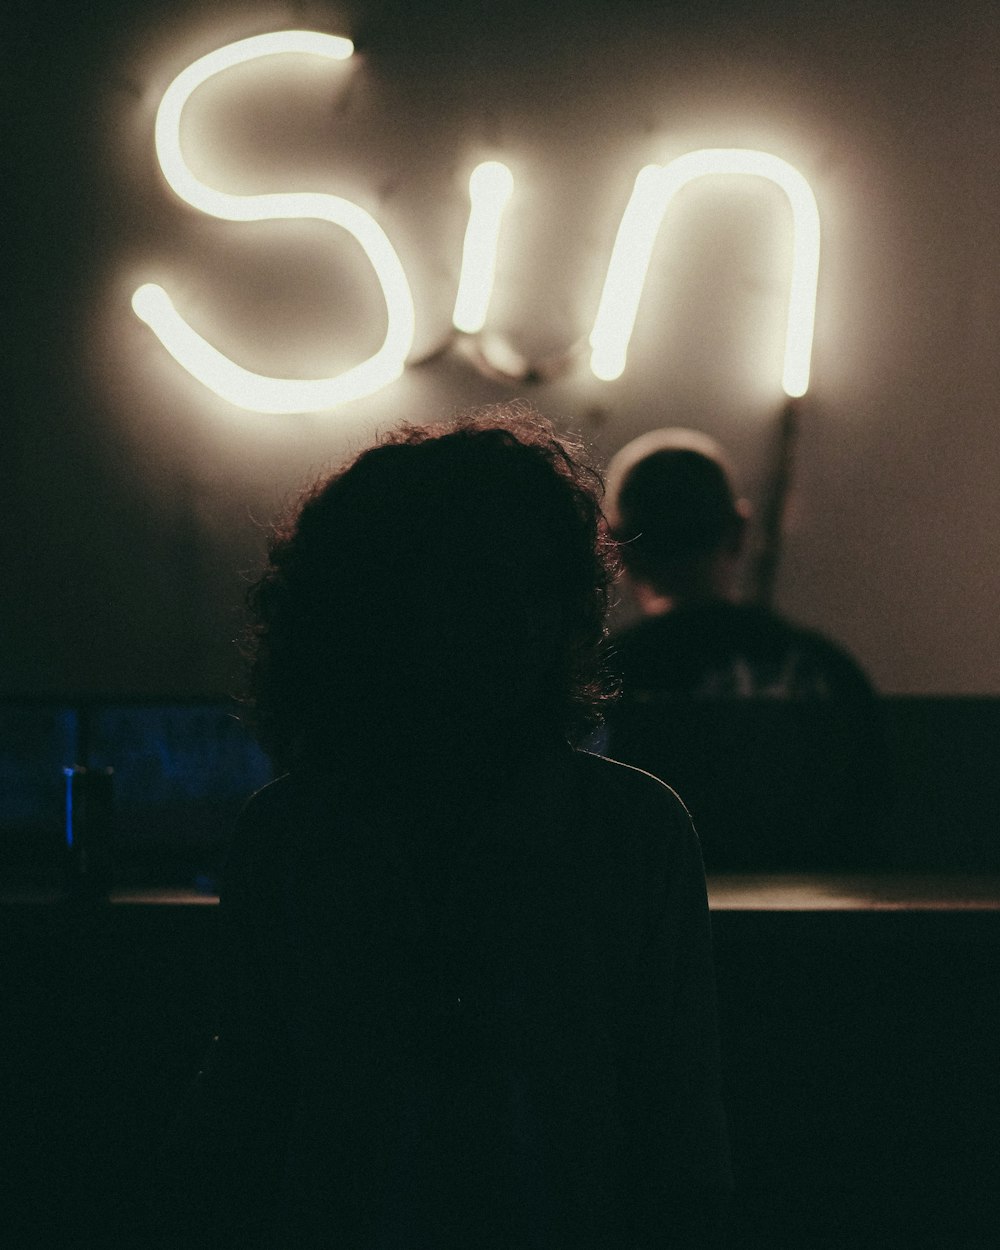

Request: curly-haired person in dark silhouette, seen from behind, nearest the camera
left=152, top=405, right=730, bottom=1250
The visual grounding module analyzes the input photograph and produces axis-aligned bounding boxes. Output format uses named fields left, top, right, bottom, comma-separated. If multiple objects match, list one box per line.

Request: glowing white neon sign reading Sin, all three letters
left=133, top=30, right=820, bottom=413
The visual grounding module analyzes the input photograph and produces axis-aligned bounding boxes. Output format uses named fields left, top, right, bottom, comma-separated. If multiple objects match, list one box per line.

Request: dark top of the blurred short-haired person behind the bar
left=605, top=603, right=893, bottom=873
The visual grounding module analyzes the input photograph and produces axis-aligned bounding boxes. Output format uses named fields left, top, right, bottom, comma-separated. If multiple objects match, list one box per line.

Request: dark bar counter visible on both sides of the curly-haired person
left=0, top=878, right=1000, bottom=1250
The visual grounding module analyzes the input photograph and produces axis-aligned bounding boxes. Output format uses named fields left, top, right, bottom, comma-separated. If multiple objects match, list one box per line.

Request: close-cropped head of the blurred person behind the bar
left=606, top=429, right=746, bottom=610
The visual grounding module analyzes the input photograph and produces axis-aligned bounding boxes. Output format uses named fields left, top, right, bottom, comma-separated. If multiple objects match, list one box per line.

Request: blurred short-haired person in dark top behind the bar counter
left=605, top=429, right=884, bottom=870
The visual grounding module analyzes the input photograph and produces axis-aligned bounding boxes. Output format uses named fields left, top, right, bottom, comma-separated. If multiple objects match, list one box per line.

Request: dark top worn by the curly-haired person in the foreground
left=160, top=749, right=730, bottom=1250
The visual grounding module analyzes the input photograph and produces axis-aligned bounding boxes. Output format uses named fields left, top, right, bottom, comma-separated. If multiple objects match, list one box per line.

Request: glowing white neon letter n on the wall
left=590, top=148, right=820, bottom=398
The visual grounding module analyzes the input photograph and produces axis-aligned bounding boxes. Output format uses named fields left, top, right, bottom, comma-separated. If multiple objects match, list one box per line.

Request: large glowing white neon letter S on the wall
left=133, top=30, right=415, bottom=413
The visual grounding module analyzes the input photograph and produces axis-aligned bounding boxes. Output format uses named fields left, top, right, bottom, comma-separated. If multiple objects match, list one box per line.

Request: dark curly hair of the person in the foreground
left=244, top=403, right=616, bottom=770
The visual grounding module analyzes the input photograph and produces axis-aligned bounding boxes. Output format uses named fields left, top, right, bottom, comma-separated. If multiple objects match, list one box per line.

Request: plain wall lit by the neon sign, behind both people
left=7, top=0, right=1000, bottom=694
